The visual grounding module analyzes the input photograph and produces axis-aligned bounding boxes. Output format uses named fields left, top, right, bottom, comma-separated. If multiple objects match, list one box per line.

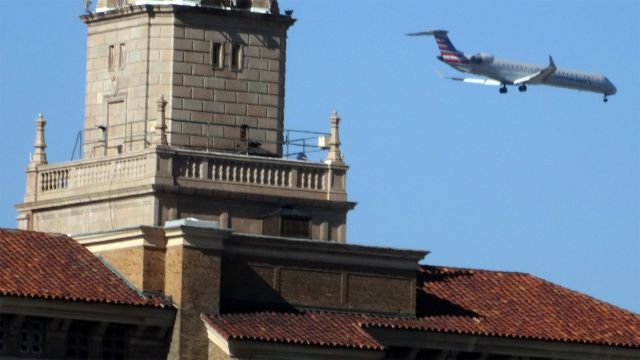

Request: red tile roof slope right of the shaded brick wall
left=400, top=266, right=640, bottom=347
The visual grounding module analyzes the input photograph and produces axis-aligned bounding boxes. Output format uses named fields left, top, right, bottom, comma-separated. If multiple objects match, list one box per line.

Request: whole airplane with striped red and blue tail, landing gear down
left=407, top=30, right=617, bottom=102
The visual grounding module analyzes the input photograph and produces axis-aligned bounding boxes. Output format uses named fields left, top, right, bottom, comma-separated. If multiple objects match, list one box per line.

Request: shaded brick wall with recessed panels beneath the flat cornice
left=222, top=256, right=416, bottom=314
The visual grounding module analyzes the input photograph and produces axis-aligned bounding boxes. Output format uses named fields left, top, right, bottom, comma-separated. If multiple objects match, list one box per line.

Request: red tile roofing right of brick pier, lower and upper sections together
left=203, top=266, right=640, bottom=350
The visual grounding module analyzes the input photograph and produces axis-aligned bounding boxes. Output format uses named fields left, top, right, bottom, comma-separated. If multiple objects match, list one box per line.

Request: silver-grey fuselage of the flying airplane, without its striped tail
left=445, top=59, right=617, bottom=95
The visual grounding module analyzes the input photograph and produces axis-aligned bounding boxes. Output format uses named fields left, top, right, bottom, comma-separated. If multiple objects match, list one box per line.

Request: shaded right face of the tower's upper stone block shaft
left=169, top=13, right=288, bottom=155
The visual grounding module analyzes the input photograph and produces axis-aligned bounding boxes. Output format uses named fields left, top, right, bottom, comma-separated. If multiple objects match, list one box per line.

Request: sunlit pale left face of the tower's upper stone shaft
left=83, top=9, right=173, bottom=158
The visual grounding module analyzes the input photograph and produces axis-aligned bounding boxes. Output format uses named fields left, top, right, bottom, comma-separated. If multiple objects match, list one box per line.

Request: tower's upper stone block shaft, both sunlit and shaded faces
left=82, top=6, right=293, bottom=158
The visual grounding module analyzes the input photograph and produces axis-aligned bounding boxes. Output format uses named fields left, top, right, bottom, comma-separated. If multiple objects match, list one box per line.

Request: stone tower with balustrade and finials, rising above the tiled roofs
left=17, top=0, right=354, bottom=242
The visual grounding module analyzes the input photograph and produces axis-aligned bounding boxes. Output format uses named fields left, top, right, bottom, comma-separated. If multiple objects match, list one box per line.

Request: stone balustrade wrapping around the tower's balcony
left=25, top=149, right=346, bottom=200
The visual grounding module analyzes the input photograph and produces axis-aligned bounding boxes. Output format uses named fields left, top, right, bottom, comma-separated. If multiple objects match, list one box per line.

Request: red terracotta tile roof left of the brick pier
left=0, top=228, right=169, bottom=307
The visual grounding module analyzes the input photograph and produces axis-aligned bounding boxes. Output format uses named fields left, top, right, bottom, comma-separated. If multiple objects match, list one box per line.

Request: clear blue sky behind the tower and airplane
left=0, top=0, right=640, bottom=312
